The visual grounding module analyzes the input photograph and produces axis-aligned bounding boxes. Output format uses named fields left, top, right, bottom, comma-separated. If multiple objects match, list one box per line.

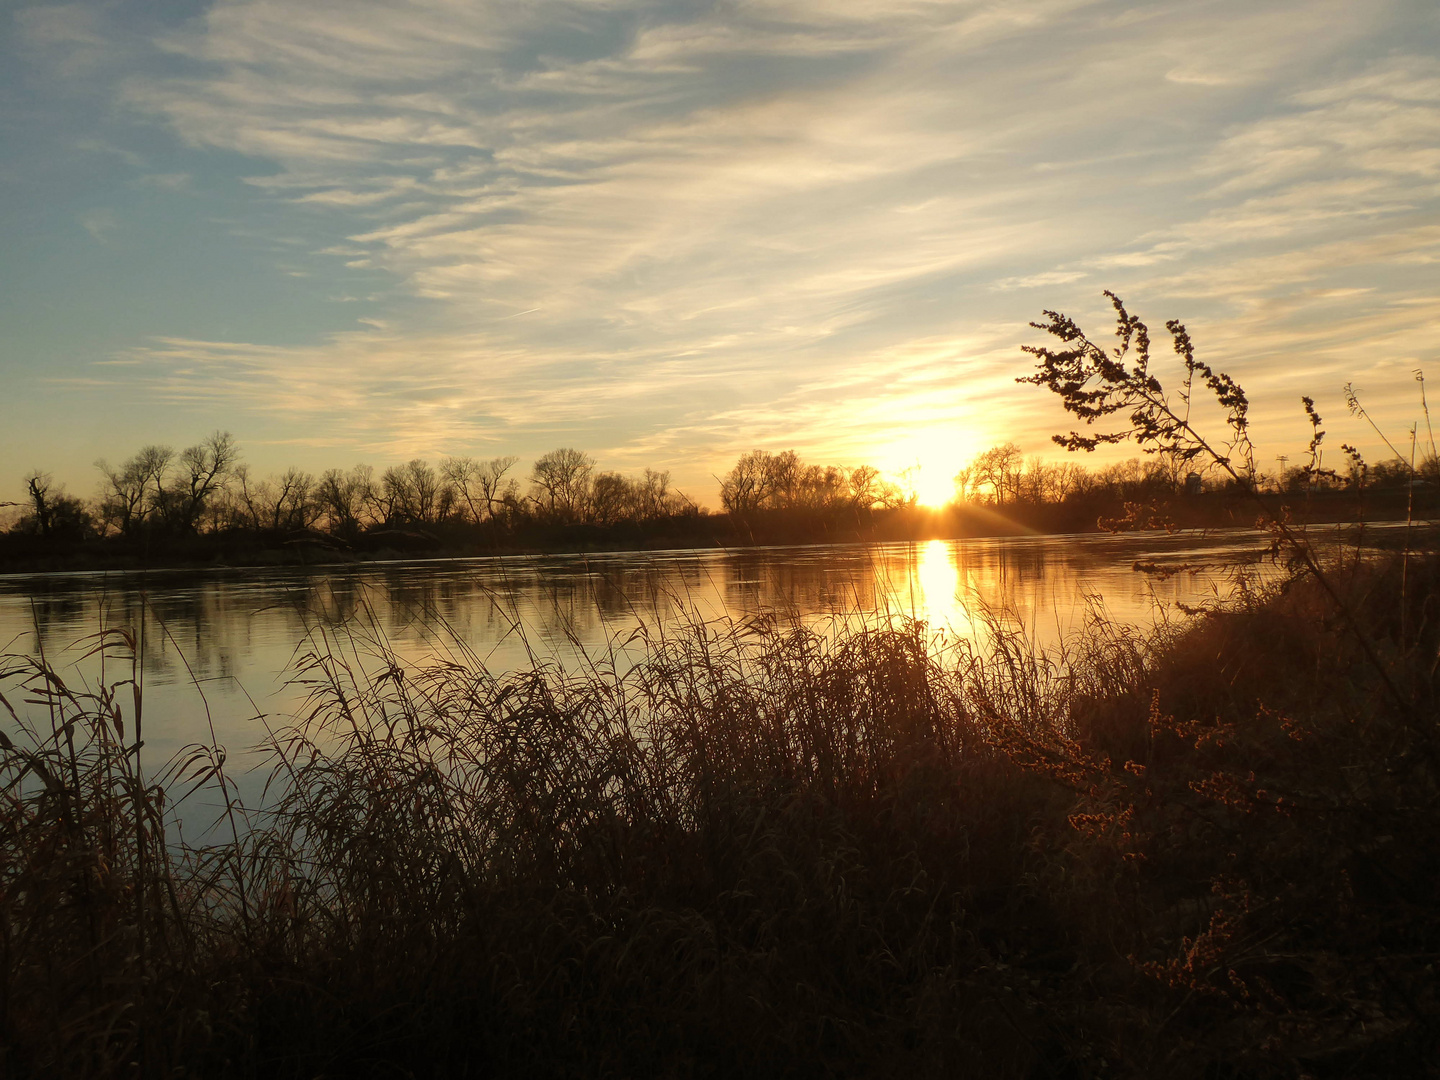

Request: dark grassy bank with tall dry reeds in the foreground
left=0, top=557, right=1440, bottom=1077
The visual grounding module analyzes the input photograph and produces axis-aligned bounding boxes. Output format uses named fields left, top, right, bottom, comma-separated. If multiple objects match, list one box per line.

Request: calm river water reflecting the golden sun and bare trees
left=0, top=530, right=1376, bottom=817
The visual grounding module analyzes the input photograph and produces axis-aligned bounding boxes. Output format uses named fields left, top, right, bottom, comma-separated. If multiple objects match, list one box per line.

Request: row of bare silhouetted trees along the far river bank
left=2, top=432, right=1440, bottom=552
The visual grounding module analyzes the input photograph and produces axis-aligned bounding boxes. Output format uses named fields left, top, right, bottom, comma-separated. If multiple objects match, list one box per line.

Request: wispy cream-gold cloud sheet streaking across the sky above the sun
left=11, top=0, right=1440, bottom=495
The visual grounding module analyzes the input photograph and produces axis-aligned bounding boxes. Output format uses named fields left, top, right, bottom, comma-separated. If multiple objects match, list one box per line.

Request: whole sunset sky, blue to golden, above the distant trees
left=0, top=0, right=1440, bottom=505
